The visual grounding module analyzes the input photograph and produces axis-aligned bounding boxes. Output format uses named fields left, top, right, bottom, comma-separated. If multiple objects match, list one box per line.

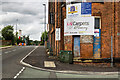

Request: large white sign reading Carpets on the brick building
left=64, top=17, right=94, bottom=36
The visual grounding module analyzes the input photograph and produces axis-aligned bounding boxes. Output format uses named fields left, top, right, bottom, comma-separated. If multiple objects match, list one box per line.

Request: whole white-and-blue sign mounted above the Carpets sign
left=66, top=2, right=92, bottom=18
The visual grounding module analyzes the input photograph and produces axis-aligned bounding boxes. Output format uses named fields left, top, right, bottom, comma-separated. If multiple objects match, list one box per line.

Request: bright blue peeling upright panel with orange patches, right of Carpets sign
left=93, top=29, right=101, bottom=58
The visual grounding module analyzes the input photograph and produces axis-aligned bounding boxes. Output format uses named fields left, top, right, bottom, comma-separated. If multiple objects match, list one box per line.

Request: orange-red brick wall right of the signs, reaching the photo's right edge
left=92, top=2, right=120, bottom=58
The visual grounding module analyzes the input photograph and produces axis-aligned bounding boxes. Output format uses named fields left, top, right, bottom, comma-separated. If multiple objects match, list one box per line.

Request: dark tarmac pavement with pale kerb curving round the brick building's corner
left=22, top=46, right=119, bottom=74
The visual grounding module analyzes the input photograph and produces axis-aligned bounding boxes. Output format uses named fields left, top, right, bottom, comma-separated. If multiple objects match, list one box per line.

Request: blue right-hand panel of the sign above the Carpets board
left=81, top=2, right=92, bottom=15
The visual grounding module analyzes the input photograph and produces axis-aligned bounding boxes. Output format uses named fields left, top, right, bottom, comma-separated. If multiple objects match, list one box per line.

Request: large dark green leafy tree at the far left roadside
left=2, top=25, right=15, bottom=44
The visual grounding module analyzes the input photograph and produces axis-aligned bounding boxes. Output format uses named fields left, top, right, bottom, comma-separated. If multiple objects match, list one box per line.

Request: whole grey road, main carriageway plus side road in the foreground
left=2, top=46, right=119, bottom=80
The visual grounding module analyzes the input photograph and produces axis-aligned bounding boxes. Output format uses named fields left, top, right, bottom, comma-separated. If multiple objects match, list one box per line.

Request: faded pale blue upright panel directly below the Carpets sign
left=74, top=37, right=80, bottom=57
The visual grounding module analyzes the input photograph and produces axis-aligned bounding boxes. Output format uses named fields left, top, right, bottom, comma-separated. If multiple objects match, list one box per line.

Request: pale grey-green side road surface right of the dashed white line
left=17, top=67, right=118, bottom=80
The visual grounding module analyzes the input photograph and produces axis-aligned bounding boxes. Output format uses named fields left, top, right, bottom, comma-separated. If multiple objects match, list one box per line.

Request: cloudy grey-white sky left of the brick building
left=0, top=0, right=48, bottom=40
